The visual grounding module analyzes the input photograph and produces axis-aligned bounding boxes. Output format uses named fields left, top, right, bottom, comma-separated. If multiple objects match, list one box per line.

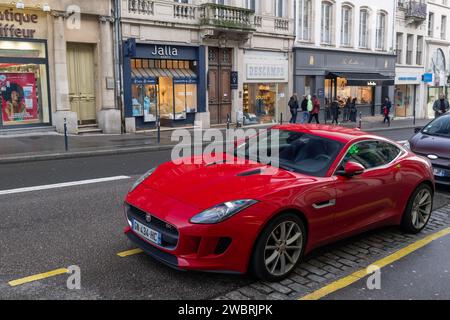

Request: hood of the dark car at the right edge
left=410, top=133, right=450, bottom=159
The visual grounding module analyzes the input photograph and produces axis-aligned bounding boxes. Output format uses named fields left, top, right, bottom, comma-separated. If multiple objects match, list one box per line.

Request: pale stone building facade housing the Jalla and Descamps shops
left=120, top=0, right=294, bottom=132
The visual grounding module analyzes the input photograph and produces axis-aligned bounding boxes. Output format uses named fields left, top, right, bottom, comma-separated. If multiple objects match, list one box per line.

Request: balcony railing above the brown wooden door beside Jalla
left=200, top=3, right=255, bottom=31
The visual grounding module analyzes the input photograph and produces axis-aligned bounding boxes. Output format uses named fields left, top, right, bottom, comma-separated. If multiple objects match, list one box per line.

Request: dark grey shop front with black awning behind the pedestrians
left=294, top=48, right=395, bottom=116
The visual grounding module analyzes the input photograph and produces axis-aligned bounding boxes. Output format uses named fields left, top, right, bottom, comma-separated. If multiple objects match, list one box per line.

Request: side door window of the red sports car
left=342, top=140, right=392, bottom=169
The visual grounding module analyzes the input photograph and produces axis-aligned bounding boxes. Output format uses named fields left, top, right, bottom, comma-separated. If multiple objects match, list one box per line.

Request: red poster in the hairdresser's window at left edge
left=0, top=73, right=39, bottom=123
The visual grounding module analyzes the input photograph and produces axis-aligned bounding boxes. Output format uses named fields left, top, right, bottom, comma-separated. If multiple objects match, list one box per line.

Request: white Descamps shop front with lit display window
left=243, top=50, right=289, bottom=124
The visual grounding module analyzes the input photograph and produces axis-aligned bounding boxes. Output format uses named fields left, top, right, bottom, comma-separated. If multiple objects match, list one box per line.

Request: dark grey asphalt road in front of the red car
left=0, top=130, right=450, bottom=299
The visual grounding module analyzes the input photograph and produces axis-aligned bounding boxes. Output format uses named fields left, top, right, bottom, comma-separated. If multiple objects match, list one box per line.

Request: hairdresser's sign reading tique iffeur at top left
left=0, top=9, right=38, bottom=38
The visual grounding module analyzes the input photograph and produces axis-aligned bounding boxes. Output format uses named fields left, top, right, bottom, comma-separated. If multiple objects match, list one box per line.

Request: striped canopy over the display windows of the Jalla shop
left=131, top=68, right=197, bottom=84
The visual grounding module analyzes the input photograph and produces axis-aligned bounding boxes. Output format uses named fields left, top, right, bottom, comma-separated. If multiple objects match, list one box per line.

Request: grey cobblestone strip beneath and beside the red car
left=216, top=205, right=450, bottom=300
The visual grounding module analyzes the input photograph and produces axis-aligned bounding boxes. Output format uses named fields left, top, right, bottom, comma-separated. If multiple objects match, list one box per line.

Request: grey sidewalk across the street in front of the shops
left=0, top=117, right=429, bottom=163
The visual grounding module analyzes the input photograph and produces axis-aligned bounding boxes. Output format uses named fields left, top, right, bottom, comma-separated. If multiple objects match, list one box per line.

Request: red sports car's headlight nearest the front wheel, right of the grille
left=191, top=199, right=258, bottom=224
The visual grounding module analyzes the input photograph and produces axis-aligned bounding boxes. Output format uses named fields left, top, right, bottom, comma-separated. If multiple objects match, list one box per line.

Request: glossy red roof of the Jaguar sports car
left=272, top=124, right=387, bottom=144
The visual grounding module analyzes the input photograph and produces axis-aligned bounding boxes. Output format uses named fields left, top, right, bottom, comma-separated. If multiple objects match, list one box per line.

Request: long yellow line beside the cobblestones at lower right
left=299, top=228, right=450, bottom=300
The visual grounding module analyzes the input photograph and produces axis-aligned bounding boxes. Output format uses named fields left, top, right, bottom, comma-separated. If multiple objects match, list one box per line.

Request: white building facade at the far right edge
left=425, top=0, right=450, bottom=119
